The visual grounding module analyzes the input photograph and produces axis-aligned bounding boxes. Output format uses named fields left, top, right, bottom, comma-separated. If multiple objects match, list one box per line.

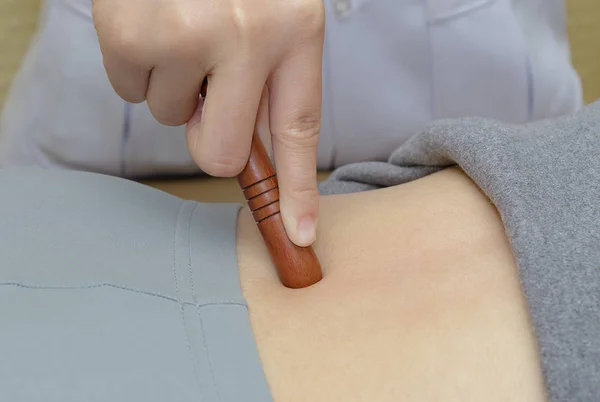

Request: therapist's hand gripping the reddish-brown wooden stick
left=93, top=0, right=325, bottom=246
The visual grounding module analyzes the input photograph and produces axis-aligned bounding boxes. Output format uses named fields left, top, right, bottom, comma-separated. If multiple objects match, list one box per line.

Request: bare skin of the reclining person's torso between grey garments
left=238, top=169, right=546, bottom=402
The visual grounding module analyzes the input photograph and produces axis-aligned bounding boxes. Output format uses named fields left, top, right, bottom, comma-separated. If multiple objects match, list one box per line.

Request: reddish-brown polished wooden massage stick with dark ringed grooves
left=200, top=79, right=323, bottom=289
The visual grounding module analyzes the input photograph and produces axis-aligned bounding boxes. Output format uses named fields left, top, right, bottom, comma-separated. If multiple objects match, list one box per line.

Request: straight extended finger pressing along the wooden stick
left=269, top=49, right=322, bottom=246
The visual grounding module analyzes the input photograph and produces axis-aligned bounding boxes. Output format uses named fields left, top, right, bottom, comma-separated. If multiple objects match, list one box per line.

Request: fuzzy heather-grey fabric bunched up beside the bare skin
left=321, top=102, right=600, bottom=402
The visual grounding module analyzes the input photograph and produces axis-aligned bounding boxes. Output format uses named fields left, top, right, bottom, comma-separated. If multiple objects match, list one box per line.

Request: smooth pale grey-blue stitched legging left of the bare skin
left=0, top=169, right=271, bottom=402
